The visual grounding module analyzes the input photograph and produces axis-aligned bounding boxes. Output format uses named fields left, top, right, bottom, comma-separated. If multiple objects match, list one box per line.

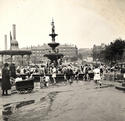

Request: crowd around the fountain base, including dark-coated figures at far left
left=1, top=63, right=124, bottom=95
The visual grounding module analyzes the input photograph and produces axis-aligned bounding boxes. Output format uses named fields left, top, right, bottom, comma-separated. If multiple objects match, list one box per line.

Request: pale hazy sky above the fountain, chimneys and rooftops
left=0, top=0, right=125, bottom=49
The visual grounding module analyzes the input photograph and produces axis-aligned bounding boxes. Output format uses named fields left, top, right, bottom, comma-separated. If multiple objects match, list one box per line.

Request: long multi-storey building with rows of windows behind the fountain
left=22, top=44, right=78, bottom=64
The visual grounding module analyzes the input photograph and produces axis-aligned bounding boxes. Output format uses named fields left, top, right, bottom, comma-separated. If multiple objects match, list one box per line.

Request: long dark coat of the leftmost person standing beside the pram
left=1, top=67, right=11, bottom=90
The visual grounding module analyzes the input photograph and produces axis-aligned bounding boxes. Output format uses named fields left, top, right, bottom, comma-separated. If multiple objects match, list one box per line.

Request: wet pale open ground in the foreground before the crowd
left=0, top=81, right=125, bottom=121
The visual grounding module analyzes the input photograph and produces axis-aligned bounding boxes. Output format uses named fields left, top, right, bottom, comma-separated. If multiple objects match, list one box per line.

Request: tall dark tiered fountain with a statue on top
left=44, top=20, right=63, bottom=67
